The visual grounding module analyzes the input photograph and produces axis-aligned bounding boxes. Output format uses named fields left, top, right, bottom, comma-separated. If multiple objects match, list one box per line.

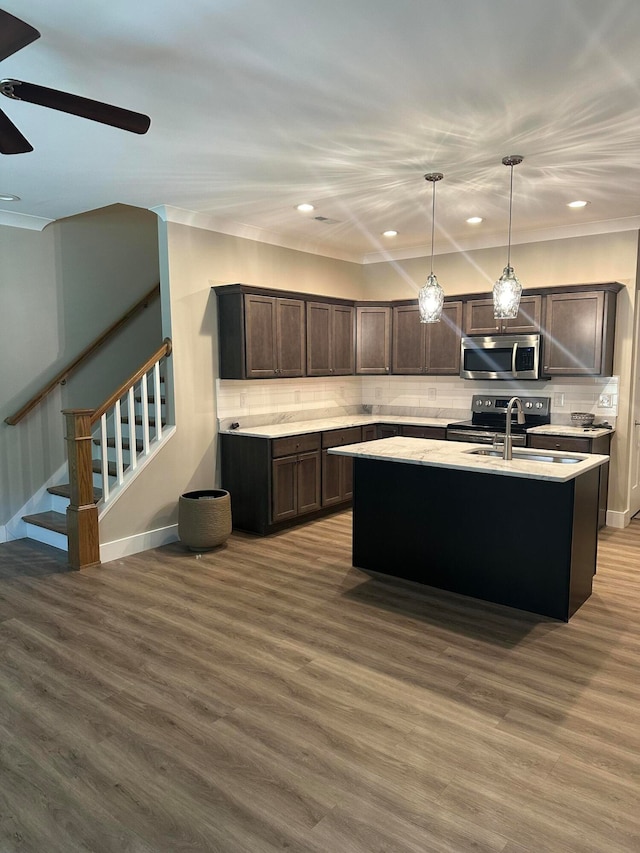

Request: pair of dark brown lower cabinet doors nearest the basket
left=271, top=450, right=321, bottom=524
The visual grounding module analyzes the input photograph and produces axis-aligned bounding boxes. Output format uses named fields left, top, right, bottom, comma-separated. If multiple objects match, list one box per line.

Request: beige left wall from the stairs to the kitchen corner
left=100, top=222, right=364, bottom=543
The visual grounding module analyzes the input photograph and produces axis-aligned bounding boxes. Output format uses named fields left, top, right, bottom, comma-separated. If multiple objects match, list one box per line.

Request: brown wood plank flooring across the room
left=0, top=512, right=640, bottom=853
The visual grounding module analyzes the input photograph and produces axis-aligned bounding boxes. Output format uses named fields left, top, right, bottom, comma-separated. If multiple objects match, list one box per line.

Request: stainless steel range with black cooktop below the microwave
left=447, top=394, right=551, bottom=447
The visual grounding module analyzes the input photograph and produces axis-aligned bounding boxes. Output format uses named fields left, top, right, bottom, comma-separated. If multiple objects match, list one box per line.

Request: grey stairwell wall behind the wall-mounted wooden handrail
left=0, top=205, right=161, bottom=524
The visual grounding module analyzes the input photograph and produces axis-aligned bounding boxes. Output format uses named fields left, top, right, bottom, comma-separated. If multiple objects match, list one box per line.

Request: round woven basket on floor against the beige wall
left=178, top=489, right=231, bottom=551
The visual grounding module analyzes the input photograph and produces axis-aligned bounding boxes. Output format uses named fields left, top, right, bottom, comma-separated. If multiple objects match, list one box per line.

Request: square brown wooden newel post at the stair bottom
left=62, top=409, right=100, bottom=569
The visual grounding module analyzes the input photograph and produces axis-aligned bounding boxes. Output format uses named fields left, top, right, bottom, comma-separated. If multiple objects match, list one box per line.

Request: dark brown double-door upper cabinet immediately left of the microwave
left=392, top=300, right=462, bottom=376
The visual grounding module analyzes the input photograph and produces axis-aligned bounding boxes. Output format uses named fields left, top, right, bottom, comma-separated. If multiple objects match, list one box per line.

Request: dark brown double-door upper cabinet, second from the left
left=307, top=302, right=355, bottom=376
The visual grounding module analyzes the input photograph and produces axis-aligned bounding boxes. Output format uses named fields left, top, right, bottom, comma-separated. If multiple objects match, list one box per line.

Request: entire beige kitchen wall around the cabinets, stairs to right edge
left=101, top=222, right=638, bottom=543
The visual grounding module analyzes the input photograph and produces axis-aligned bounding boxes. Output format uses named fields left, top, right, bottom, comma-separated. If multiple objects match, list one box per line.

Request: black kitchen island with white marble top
left=329, top=437, right=609, bottom=621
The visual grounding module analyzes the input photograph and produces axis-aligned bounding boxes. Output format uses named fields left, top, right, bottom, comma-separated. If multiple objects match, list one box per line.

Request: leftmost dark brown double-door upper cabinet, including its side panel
left=216, top=285, right=306, bottom=379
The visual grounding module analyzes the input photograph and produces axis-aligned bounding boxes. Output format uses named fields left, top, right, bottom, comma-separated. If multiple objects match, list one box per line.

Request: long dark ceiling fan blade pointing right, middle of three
left=0, top=80, right=151, bottom=133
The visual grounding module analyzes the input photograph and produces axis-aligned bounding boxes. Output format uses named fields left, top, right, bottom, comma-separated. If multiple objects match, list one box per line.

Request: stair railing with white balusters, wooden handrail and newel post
left=62, top=338, right=171, bottom=569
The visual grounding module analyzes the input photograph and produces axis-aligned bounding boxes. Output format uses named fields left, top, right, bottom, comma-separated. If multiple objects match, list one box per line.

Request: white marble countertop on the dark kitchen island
left=329, top=436, right=609, bottom=483
